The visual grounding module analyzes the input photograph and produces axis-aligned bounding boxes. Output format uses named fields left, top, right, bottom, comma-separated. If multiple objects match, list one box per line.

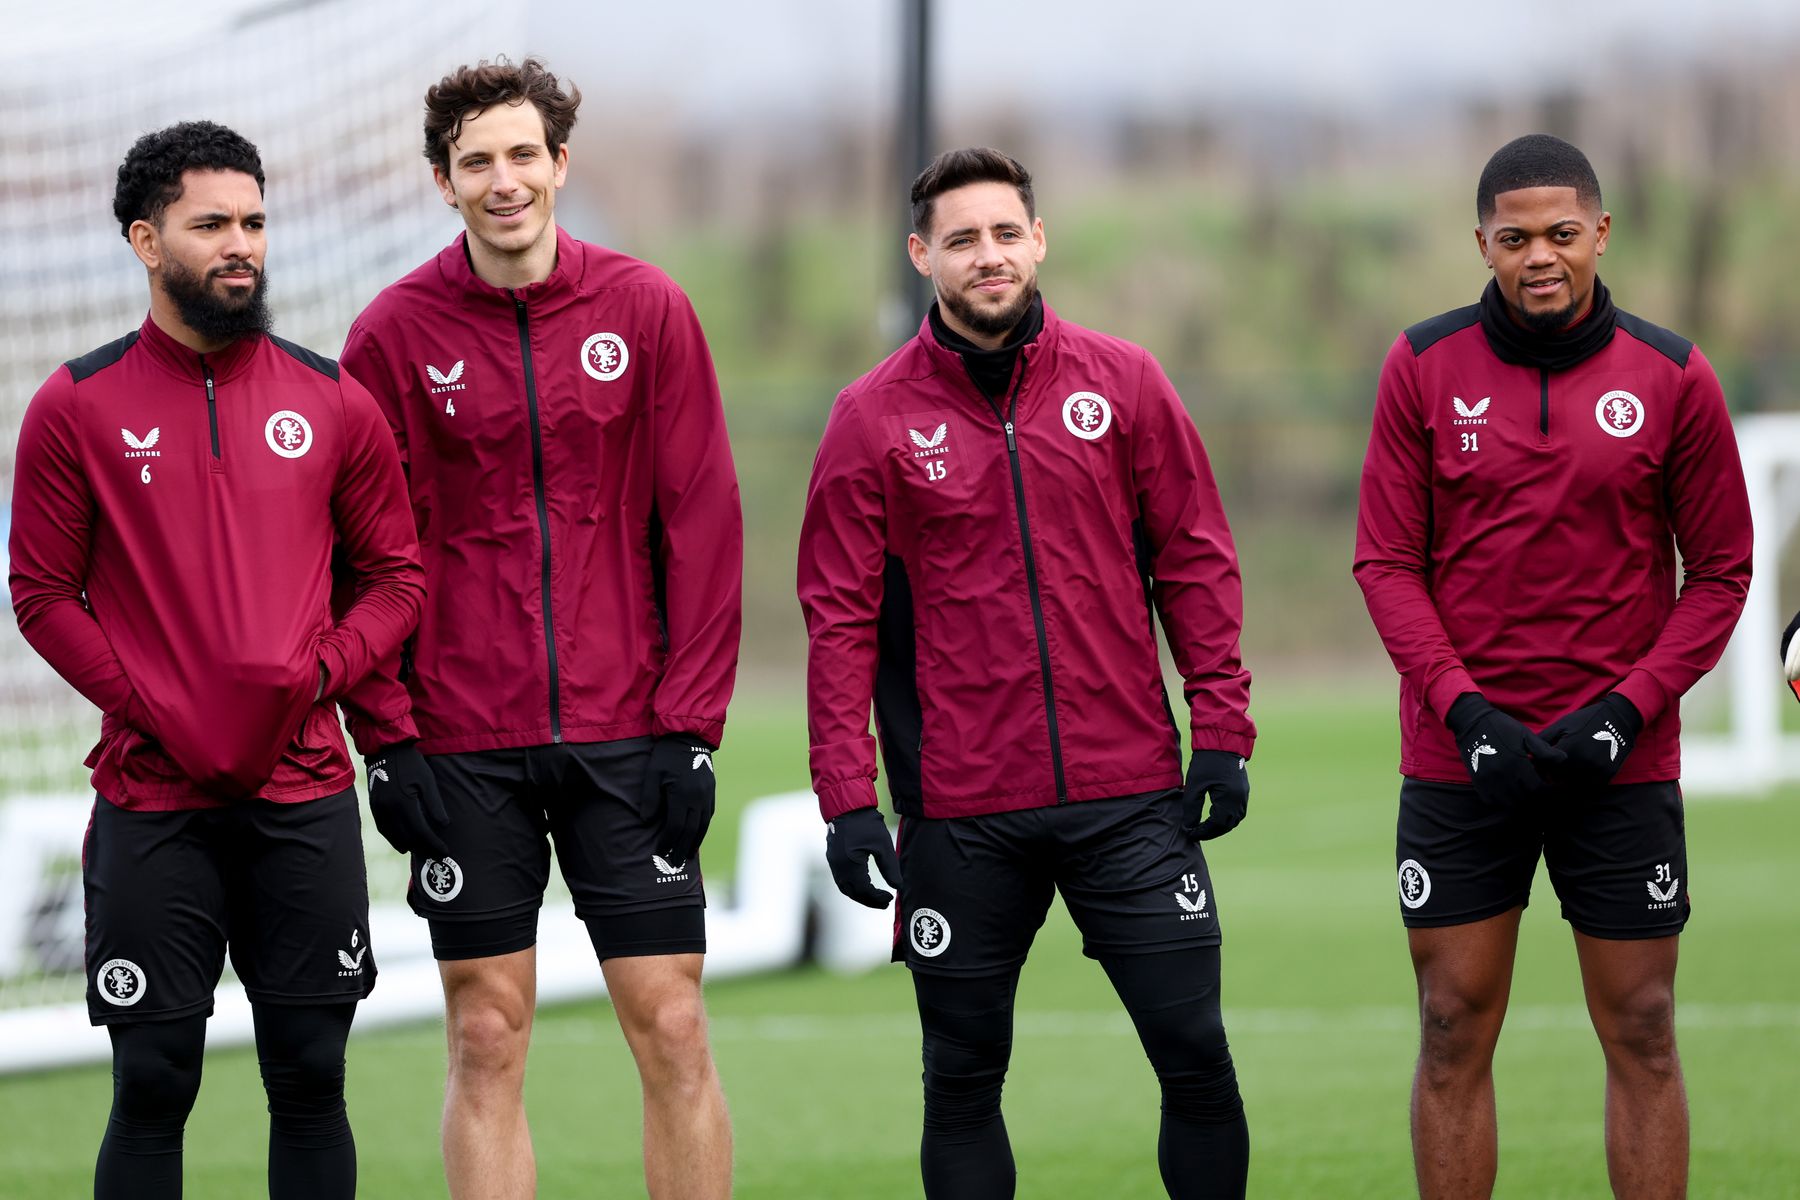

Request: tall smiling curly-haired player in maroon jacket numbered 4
left=344, top=59, right=743, bottom=1198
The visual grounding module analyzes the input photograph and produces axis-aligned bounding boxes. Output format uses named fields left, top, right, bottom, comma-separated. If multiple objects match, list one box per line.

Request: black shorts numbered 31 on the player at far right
left=1395, top=779, right=1688, bottom=941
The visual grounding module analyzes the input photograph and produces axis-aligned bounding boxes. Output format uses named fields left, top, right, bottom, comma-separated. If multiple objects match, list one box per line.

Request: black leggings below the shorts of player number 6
left=94, top=1004, right=356, bottom=1200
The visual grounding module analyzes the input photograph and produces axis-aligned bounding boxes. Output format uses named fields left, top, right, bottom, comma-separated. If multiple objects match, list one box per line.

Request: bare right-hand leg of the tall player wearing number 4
left=601, top=954, right=731, bottom=1200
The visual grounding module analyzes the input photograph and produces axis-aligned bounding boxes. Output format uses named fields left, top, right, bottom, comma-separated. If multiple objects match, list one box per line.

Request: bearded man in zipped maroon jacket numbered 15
left=799, top=149, right=1255, bottom=1200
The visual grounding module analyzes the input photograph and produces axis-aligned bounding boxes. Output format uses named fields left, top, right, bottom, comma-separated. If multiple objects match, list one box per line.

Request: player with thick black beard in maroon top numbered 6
left=11, top=121, right=425, bottom=1200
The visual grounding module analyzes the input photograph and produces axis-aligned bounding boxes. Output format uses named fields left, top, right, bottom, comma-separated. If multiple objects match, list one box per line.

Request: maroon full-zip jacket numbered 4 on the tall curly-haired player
left=344, top=230, right=743, bottom=754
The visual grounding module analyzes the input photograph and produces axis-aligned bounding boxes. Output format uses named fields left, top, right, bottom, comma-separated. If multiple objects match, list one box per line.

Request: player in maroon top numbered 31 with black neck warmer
left=1355, top=135, right=1750, bottom=1198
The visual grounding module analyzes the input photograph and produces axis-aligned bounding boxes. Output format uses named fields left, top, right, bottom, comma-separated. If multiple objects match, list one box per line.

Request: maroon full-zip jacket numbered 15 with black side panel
left=799, top=306, right=1256, bottom=820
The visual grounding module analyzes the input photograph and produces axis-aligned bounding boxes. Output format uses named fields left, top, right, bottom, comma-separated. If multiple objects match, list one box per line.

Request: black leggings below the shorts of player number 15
left=913, top=946, right=1249, bottom=1200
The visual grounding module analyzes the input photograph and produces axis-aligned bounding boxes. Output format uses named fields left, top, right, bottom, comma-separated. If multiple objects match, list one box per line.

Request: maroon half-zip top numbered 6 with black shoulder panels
left=11, top=320, right=425, bottom=810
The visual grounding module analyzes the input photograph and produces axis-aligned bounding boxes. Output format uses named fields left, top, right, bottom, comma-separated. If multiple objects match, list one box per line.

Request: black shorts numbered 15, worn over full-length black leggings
left=893, top=790, right=1219, bottom=975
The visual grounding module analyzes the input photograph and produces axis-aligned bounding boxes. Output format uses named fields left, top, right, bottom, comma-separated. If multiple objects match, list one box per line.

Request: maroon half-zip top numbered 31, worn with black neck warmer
left=1355, top=306, right=1750, bottom=783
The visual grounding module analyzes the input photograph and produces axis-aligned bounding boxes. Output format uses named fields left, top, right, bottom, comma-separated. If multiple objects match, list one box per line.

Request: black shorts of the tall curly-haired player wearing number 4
left=407, top=738, right=706, bottom=959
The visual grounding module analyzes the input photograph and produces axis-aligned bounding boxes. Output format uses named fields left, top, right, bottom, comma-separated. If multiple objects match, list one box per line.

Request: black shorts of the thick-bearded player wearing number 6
left=81, top=790, right=374, bottom=1025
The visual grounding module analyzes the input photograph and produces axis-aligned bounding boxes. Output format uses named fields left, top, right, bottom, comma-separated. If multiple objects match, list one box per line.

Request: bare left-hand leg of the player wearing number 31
left=1406, top=909, right=1525, bottom=1200
